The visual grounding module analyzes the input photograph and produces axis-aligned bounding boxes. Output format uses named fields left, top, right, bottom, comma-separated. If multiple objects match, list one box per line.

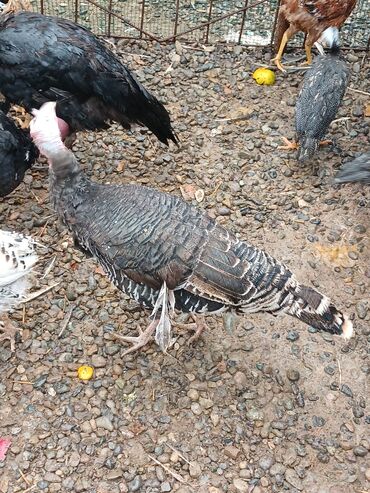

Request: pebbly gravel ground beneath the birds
left=0, top=42, right=370, bottom=493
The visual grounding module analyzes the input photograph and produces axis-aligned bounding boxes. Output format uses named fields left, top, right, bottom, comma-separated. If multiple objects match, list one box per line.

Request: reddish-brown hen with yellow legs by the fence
left=273, top=0, right=356, bottom=72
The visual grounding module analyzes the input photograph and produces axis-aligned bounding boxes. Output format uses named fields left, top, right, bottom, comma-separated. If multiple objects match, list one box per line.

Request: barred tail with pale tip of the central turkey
left=288, top=285, right=353, bottom=339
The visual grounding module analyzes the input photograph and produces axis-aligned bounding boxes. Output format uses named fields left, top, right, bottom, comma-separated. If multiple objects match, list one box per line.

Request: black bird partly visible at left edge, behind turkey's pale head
left=0, top=111, right=39, bottom=197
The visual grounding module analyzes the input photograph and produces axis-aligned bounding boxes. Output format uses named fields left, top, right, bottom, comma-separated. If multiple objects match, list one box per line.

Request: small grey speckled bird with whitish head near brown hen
left=281, top=28, right=349, bottom=161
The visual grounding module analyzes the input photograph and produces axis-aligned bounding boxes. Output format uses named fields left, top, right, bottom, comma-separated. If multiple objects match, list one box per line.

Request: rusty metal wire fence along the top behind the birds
left=32, top=0, right=370, bottom=49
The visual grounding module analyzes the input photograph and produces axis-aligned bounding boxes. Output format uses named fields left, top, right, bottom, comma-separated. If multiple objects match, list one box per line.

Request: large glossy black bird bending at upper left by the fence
left=0, top=6, right=178, bottom=144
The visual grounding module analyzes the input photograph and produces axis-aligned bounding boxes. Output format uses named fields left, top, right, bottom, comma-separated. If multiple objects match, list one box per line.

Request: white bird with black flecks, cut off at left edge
left=0, top=230, right=37, bottom=351
